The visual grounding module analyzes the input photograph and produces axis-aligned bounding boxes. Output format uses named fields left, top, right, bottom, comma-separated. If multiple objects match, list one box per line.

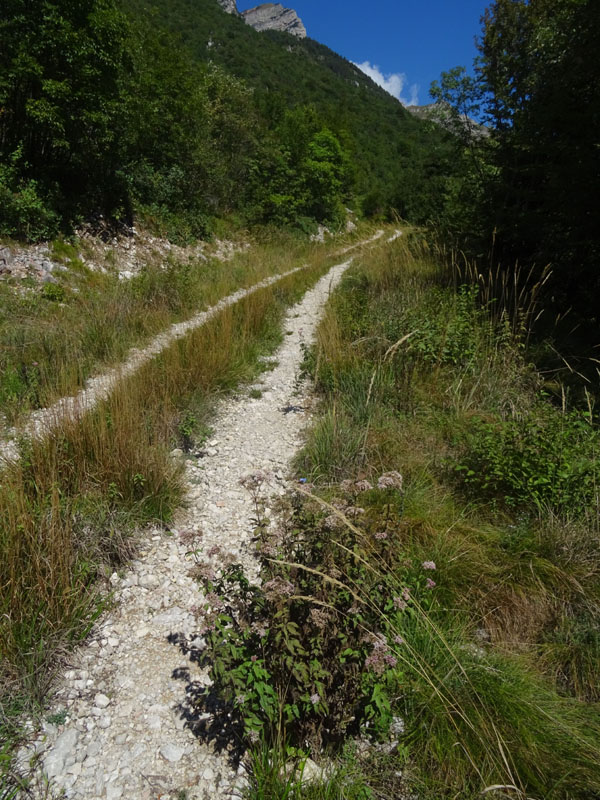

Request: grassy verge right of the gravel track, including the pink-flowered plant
left=196, top=234, right=600, bottom=800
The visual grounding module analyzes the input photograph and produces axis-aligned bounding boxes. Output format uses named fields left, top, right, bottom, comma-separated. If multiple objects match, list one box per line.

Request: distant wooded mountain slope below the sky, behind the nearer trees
left=122, top=0, right=446, bottom=218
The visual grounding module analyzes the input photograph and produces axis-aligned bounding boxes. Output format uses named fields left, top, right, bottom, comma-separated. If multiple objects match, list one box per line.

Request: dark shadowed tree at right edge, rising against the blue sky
left=479, top=0, right=600, bottom=324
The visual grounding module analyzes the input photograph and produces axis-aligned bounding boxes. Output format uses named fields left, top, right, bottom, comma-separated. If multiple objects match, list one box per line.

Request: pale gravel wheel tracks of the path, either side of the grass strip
left=17, top=255, right=351, bottom=800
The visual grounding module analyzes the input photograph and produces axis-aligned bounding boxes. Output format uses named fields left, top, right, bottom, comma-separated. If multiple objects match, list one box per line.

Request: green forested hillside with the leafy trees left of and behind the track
left=0, top=0, right=453, bottom=240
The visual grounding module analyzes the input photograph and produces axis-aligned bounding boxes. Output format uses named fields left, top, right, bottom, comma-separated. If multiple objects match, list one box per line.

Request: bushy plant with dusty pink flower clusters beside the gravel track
left=192, top=484, right=436, bottom=753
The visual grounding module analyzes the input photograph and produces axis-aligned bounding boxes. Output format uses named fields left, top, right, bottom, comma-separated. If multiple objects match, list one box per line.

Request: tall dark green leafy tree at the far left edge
left=0, top=0, right=127, bottom=225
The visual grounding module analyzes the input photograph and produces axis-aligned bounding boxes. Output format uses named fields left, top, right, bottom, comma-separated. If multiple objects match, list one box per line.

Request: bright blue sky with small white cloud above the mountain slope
left=238, top=0, right=491, bottom=105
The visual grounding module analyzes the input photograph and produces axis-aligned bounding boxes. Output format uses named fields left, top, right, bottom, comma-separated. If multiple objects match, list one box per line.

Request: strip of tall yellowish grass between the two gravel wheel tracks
left=0, top=242, right=350, bottom=780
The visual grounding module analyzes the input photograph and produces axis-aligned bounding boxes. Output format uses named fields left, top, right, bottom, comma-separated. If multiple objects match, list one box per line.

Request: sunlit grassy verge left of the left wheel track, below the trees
left=0, top=225, right=368, bottom=430
